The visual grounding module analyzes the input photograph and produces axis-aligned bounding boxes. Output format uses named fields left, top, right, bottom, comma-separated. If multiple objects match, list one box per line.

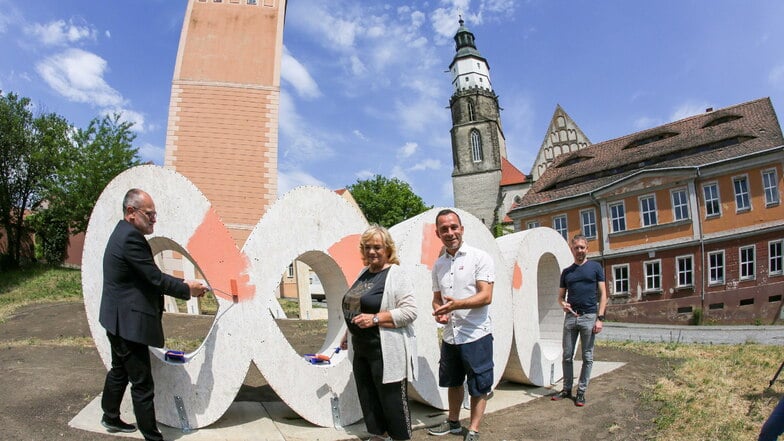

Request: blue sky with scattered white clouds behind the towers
left=0, top=0, right=784, bottom=206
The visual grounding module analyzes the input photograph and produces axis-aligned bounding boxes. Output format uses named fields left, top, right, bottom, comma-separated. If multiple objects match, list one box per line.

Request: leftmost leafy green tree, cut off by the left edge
left=0, top=93, right=69, bottom=267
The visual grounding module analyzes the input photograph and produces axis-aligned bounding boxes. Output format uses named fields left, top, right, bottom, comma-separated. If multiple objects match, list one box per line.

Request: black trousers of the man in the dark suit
left=101, top=332, right=163, bottom=441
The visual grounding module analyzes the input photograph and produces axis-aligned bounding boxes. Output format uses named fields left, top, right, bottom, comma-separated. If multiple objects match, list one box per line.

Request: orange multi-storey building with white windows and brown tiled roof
left=509, top=98, right=784, bottom=323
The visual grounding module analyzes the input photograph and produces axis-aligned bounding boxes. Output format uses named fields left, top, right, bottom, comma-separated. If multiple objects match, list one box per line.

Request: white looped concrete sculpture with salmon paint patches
left=82, top=165, right=571, bottom=428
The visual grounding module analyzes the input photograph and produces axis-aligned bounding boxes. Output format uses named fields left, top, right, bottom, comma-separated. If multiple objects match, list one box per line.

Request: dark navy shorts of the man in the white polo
left=438, top=334, right=493, bottom=397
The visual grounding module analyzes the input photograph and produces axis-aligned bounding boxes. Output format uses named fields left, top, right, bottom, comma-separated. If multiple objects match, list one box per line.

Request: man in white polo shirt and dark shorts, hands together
left=428, top=209, right=495, bottom=441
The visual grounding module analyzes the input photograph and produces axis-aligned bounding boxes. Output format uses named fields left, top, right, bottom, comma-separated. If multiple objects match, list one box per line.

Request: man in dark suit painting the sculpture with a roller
left=99, top=189, right=207, bottom=441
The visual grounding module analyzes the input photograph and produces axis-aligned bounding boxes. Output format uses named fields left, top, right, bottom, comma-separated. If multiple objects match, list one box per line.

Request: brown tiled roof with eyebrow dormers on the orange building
left=517, top=98, right=784, bottom=209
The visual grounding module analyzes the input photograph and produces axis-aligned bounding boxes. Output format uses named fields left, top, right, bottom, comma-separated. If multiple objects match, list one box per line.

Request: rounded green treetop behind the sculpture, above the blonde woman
left=347, top=175, right=432, bottom=228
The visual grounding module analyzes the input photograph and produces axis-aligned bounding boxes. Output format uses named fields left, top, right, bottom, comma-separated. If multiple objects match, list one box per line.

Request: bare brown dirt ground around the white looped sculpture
left=0, top=303, right=672, bottom=441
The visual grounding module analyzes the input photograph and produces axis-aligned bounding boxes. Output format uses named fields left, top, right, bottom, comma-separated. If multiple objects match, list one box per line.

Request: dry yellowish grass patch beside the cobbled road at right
left=601, top=342, right=784, bottom=441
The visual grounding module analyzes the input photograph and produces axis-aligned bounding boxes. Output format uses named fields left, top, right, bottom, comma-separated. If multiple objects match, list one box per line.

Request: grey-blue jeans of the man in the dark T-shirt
left=563, top=313, right=596, bottom=393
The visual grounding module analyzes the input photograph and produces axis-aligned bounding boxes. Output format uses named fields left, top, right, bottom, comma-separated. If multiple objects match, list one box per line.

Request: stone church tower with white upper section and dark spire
left=449, top=18, right=506, bottom=228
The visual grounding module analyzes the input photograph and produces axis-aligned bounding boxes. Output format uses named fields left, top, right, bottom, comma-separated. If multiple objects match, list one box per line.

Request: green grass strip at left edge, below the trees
left=0, top=265, right=82, bottom=323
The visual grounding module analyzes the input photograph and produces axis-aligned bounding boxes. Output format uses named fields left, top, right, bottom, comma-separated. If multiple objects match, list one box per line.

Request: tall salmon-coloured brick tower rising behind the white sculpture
left=165, top=0, right=286, bottom=247
